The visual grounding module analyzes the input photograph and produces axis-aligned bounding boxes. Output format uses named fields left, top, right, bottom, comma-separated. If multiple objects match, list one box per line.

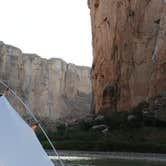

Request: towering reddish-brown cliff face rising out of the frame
left=88, top=0, right=166, bottom=113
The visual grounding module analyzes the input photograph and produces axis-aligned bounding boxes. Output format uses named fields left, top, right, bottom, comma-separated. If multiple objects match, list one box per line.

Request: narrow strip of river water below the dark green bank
left=48, top=151, right=166, bottom=166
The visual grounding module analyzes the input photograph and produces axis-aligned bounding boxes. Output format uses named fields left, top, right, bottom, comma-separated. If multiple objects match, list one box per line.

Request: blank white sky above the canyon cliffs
left=0, top=0, right=92, bottom=66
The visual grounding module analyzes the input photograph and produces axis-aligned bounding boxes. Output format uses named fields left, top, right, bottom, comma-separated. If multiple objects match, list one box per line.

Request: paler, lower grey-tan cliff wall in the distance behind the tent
left=0, top=42, right=91, bottom=121
